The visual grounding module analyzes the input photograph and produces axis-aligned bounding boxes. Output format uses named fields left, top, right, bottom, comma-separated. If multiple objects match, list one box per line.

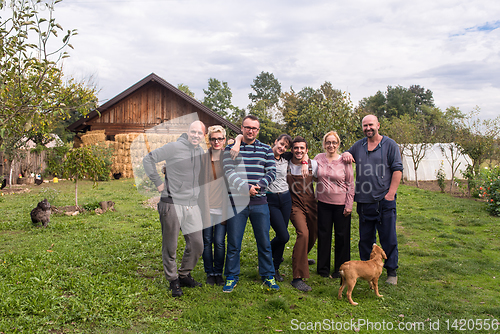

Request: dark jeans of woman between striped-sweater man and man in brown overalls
left=267, top=191, right=292, bottom=270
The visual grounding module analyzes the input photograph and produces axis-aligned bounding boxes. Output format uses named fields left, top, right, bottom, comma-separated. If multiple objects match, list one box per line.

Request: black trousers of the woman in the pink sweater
left=317, top=201, right=351, bottom=276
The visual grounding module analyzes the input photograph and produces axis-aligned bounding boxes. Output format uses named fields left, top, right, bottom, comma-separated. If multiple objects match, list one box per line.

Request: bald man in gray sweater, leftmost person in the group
left=143, top=121, right=205, bottom=297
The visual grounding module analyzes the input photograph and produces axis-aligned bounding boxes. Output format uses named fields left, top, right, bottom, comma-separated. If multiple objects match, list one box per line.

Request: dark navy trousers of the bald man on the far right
left=357, top=199, right=398, bottom=271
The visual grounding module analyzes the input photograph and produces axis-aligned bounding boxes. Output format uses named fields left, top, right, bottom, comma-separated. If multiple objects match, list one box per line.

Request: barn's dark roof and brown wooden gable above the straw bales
left=68, top=73, right=241, bottom=140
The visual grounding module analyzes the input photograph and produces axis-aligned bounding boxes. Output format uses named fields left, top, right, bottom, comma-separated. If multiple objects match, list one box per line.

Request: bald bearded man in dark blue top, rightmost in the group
left=342, top=115, right=403, bottom=285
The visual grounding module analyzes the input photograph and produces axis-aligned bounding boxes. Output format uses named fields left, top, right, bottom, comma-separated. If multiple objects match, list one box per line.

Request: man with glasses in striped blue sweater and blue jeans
left=222, top=115, right=279, bottom=292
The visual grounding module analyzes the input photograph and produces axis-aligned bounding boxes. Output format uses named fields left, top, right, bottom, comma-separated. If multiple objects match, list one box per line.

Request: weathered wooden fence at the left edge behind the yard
left=0, top=150, right=47, bottom=184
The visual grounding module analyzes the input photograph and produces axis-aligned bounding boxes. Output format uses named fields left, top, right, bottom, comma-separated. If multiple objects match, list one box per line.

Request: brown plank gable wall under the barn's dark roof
left=88, top=82, right=218, bottom=136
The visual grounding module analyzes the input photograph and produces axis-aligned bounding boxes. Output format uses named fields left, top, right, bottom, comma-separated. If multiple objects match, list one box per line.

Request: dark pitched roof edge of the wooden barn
left=67, top=73, right=241, bottom=133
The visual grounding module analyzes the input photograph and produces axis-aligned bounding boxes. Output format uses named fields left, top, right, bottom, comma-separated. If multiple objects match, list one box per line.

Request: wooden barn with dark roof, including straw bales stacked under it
left=68, top=73, right=241, bottom=178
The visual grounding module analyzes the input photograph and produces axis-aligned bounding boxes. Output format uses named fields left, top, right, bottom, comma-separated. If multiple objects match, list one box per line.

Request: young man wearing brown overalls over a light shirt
left=287, top=136, right=318, bottom=292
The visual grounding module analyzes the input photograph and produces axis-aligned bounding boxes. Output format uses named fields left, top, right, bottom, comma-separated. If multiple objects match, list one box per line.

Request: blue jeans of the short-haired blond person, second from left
left=203, top=214, right=226, bottom=276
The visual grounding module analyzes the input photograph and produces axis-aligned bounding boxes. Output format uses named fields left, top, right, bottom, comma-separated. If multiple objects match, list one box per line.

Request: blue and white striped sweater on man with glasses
left=223, top=140, right=276, bottom=206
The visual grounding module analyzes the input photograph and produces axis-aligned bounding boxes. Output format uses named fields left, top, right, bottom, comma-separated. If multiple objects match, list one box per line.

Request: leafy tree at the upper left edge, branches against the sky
left=0, top=0, right=97, bottom=146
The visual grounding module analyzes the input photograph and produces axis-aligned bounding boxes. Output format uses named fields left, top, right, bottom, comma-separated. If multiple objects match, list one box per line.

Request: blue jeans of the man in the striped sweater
left=224, top=204, right=274, bottom=278
